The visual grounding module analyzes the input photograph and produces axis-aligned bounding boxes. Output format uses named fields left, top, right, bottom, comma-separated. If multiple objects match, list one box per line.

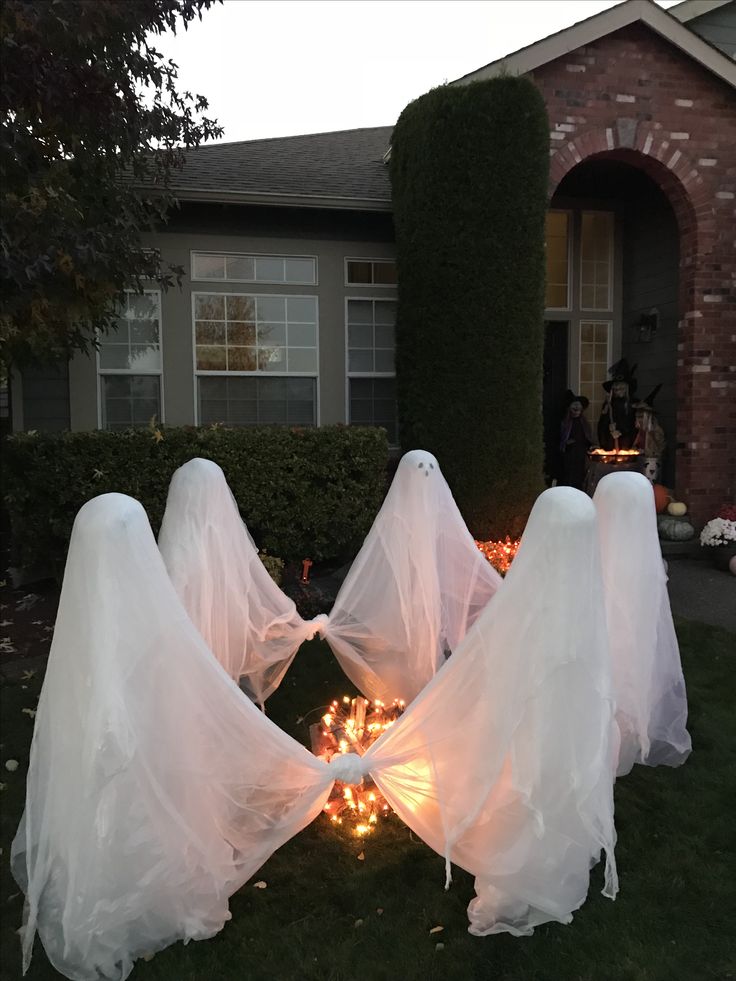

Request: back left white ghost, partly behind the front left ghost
left=158, top=459, right=315, bottom=706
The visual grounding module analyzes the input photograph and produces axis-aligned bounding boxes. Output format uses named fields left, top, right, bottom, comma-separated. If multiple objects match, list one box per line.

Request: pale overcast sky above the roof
left=158, top=0, right=676, bottom=142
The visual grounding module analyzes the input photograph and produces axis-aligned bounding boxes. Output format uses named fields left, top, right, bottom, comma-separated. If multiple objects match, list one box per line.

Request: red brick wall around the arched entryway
left=533, top=25, right=736, bottom=523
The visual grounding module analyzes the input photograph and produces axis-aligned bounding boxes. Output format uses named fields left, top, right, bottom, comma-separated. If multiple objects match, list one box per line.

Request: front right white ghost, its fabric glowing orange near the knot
left=362, top=487, right=618, bottom=935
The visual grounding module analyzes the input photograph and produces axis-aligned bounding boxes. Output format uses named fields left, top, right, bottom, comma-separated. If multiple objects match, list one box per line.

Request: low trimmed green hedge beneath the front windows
left=3, top=426, right=388, bottom=574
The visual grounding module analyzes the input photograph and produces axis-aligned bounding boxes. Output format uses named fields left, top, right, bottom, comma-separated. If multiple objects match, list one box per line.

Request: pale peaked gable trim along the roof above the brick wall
left=452, top=0, right=736, bottom=87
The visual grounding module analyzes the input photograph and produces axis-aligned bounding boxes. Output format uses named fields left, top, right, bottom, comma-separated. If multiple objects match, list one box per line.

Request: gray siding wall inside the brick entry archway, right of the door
left=622, top=189, right=679, bottom=486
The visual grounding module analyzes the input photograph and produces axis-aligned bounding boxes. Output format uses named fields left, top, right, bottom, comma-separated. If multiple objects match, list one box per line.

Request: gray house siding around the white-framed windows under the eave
left=70, top=204, right=396, bottom=429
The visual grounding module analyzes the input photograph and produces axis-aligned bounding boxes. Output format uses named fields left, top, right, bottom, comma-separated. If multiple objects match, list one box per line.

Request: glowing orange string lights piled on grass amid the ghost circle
left=310, top=695, right=405, bottom=838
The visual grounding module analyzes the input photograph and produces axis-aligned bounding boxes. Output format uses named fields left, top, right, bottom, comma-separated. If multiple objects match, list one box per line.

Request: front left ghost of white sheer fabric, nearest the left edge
left=11, top=494, right=333, bottom=981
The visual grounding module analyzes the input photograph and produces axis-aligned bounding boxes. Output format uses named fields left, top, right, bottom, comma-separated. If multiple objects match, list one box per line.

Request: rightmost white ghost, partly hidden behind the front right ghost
left=593, top=473, right=691, bottom=776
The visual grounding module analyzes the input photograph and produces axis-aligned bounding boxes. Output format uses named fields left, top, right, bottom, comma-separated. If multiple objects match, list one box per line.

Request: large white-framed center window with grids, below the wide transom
left=192, top=293, right=318, bottom=426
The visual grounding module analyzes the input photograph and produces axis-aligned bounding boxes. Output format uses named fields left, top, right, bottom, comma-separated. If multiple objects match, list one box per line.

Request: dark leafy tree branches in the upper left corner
left=0, top=0, right=222, bottom=365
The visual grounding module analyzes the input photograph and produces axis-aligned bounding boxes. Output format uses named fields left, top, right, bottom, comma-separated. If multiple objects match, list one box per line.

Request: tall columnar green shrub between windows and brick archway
left=391, top=77, right=549, bottom=539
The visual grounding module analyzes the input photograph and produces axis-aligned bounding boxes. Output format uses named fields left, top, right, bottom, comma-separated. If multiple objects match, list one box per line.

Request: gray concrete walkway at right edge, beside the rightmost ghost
left=667, top=557, right=736, bottom=632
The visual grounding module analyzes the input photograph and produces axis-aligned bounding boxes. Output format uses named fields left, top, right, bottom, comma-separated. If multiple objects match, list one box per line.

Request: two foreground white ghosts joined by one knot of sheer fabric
left=11, top=486, right=617, bottom=981
